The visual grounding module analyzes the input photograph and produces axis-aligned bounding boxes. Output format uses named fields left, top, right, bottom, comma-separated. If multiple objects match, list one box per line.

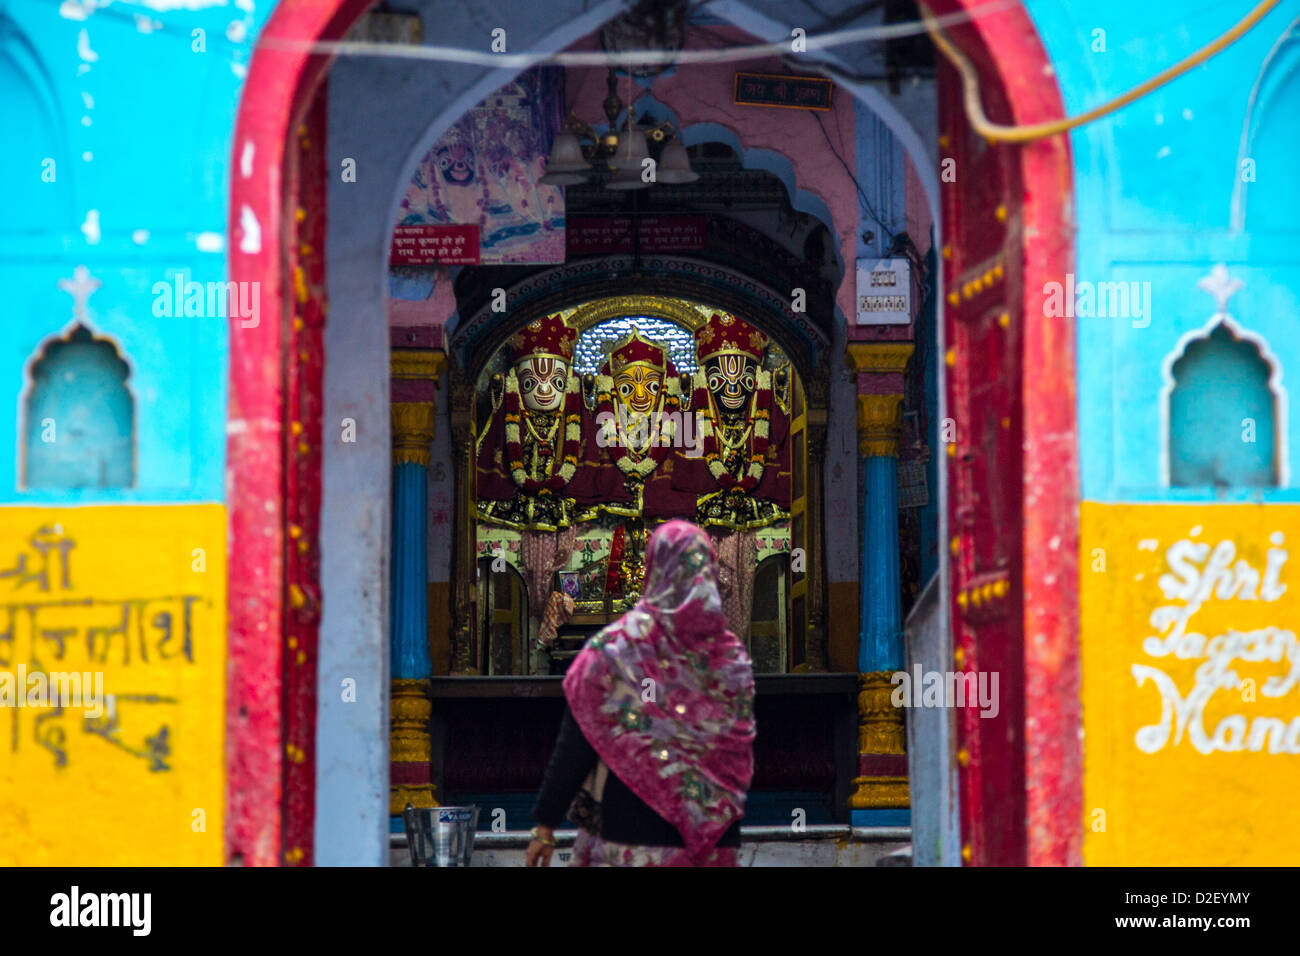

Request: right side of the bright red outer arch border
left=930, top=0, right=1083, bottom=866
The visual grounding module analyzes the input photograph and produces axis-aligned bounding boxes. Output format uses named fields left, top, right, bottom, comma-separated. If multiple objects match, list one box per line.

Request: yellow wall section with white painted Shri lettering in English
left=1079, top=502, right=1300, bottom=866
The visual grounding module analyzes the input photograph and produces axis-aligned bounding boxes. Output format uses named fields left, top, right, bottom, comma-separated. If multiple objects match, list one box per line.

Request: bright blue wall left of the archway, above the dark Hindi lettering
left=0, top=0, right=270, bottom=505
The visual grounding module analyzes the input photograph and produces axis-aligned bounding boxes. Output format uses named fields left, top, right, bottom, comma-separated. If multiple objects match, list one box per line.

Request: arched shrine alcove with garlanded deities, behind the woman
left=452, top=294, right=826, bottom=676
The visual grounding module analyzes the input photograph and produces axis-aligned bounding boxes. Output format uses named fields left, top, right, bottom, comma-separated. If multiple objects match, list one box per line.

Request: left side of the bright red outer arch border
left=225, top=0, right=372, bottom=866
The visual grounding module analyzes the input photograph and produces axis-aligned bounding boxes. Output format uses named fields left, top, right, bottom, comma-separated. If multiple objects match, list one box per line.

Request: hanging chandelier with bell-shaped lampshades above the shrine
left=540, top=66, right=699, bottom=190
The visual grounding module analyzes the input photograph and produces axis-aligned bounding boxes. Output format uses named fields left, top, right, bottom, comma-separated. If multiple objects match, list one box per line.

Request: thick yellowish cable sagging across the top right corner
left=918, top=0, right=1281, bottom=143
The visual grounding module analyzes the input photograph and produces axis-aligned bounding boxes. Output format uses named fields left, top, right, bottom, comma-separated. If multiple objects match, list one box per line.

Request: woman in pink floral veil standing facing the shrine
left=528, top=520, right=754, bottom=866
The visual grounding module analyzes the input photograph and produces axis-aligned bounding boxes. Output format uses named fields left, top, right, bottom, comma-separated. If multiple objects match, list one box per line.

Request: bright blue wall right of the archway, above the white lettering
left=1028, top=0, right=1300, bottom=502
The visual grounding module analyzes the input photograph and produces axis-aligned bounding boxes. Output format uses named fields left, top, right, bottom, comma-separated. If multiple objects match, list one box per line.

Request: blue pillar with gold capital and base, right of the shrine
left=848, top=342, right=914, bottom=825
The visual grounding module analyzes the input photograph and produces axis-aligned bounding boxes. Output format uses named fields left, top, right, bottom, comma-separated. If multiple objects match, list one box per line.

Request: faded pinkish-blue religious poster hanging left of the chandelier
left=394, top=66, right=564, bottom=265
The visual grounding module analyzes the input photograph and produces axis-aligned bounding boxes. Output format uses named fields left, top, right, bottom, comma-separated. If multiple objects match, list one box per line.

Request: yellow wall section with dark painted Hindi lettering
left=0, top=505, right=226, bottom=866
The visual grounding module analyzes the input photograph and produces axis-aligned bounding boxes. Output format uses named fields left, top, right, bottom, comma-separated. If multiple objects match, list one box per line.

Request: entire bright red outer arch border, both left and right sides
left=225, top=0, right=1082, bottom=865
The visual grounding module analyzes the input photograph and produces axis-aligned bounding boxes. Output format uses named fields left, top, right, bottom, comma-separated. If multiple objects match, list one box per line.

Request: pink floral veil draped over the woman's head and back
left=564, top=520, right=754, bottom=865
